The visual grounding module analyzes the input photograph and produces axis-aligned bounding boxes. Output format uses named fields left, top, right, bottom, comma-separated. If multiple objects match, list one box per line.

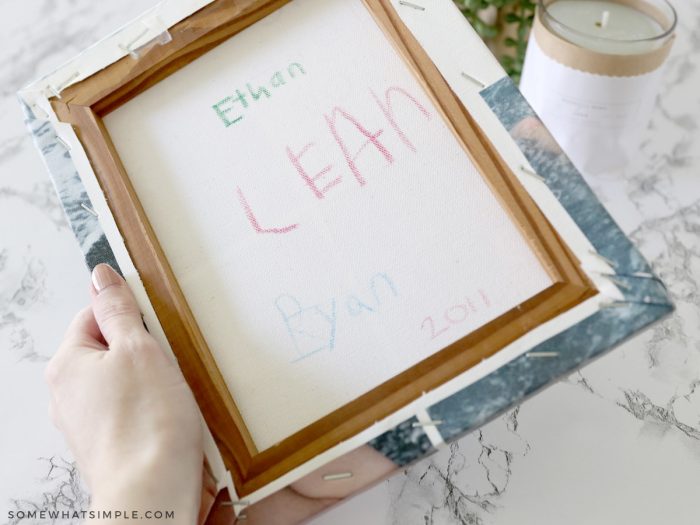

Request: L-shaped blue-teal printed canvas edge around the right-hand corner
left=428, top=77, right=673, bottom=441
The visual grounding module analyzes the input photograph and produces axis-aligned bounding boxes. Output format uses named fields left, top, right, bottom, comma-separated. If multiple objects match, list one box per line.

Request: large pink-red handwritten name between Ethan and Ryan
left=236, top=86, right=431, bottom=234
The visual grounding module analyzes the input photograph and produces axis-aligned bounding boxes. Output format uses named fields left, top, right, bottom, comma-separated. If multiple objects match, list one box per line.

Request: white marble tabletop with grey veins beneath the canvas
left=0, top=0, right=700, bottom=525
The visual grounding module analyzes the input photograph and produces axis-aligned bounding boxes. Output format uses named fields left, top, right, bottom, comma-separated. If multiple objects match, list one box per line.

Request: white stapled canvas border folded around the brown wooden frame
left=20, top=0, right=622, bottom=503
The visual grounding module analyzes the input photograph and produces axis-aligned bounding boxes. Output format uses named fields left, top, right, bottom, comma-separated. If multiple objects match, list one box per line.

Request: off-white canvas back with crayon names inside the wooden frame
left=104, top=0, right=551, bottom=450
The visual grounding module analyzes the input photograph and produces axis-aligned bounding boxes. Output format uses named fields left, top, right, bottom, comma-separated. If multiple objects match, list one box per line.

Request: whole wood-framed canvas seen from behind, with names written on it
left=21, top=0, right=671, bottom=516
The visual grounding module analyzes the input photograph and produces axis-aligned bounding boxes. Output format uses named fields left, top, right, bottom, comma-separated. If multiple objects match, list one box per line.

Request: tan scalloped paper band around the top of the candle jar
left=532, top=0, right=674, bottom=77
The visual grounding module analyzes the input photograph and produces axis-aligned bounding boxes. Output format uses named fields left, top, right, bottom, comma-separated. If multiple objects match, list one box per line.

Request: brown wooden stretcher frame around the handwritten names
left=51, top=0, right=597, bottom=497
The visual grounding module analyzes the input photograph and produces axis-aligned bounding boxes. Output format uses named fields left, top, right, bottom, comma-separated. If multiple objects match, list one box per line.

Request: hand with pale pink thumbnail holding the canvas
left=46, top=264, right=203, bottom=525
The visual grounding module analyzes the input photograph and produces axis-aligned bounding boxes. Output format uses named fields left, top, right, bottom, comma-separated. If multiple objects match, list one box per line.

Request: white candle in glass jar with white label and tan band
left=520, top=0, right=676, bottom=173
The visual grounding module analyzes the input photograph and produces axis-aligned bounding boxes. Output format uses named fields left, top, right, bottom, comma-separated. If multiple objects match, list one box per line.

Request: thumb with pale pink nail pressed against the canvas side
left=92, top=264, right=146, bottom=346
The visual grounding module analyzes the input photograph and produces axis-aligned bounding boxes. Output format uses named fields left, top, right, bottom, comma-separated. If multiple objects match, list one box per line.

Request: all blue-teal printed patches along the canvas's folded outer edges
left=23, top=78, right=673, bottom=466
